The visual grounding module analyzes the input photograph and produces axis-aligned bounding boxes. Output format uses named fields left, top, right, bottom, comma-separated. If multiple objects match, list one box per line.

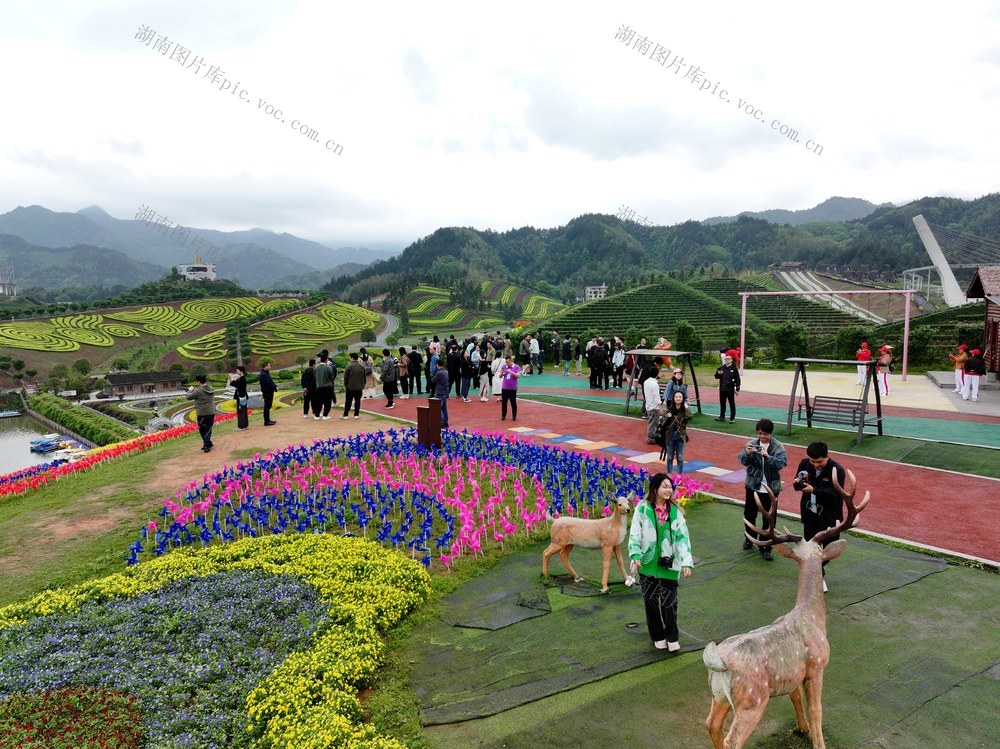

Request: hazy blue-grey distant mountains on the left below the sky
left=0, top=205, right=392, bottom=290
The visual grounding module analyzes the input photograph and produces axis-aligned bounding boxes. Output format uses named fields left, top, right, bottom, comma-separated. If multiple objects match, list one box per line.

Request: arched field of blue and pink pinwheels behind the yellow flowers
left=129, top=429, right=707, bottom=567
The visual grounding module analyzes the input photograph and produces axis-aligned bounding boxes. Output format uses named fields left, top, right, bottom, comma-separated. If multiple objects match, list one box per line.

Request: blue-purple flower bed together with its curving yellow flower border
left=0, top=535, right=429, bottom=749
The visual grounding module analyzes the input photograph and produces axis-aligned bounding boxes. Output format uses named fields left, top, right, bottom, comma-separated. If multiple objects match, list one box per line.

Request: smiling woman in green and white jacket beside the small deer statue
left=628, top=473, right=694, bottom=653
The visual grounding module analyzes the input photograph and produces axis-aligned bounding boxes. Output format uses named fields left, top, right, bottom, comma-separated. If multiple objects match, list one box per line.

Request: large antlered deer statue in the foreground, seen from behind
left=702, top=471, right=869, bottom=749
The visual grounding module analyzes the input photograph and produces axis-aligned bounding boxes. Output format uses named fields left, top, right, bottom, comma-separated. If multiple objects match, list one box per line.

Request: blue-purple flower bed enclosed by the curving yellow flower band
left=0, top=571, right=328, bottom=749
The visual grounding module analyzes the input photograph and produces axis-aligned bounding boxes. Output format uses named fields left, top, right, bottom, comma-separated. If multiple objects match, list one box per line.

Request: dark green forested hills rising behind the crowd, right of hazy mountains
left=326, top=194, right=1000, bottom=299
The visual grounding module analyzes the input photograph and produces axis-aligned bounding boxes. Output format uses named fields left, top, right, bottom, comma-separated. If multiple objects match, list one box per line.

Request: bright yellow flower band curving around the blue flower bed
left=0, top=534, right=430, bottom=749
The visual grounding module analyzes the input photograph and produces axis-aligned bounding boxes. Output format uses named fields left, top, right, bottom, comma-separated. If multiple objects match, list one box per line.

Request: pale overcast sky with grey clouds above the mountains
left=0, top=0, right=1000, bottom=250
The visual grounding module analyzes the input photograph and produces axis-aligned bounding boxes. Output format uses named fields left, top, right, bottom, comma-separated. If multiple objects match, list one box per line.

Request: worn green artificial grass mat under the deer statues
left=420, top=504, right=1000, bottom=749
